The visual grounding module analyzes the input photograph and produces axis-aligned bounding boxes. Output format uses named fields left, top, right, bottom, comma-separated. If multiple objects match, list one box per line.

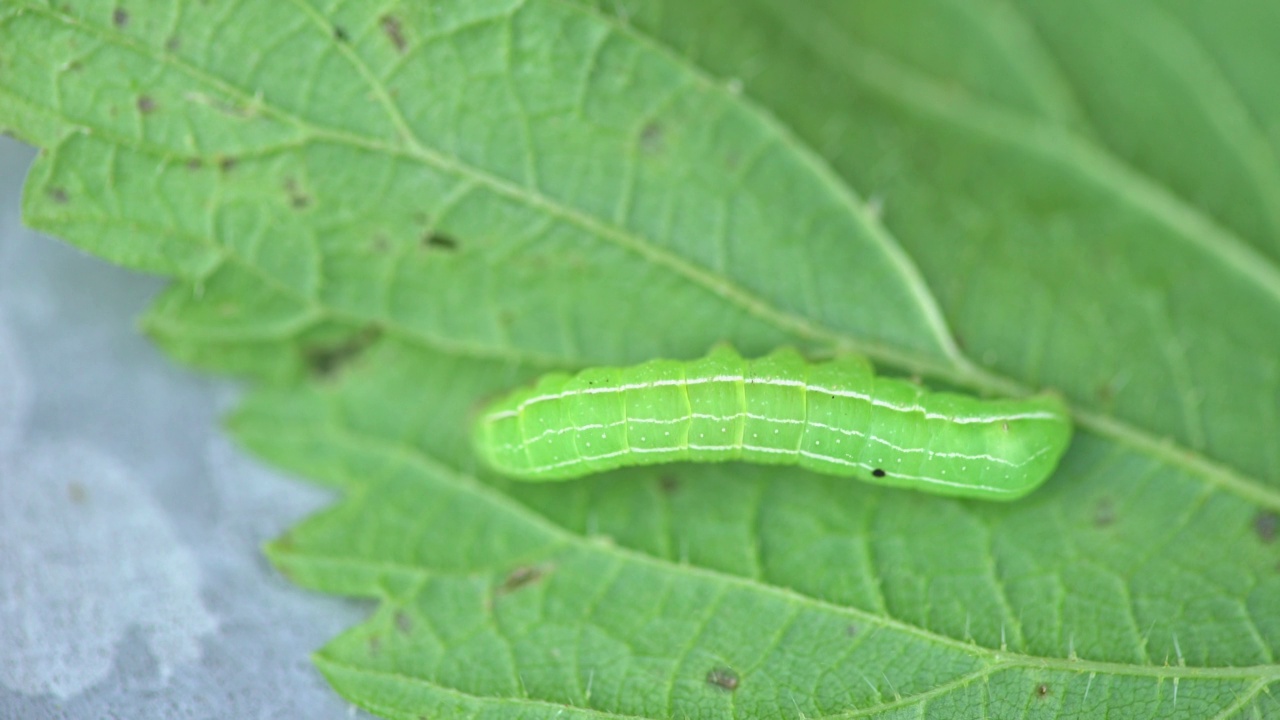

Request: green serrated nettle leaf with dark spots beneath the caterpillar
left=0, top=0, right=1280, bottom=719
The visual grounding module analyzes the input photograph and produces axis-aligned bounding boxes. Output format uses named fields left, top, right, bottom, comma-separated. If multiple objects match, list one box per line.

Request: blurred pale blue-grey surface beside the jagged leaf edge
left=0, top=137, right=369, bottom=719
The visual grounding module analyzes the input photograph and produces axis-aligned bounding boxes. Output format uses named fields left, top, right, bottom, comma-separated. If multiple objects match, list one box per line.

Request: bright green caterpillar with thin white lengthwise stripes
left=475, top=347, right=1071, bottom=500
